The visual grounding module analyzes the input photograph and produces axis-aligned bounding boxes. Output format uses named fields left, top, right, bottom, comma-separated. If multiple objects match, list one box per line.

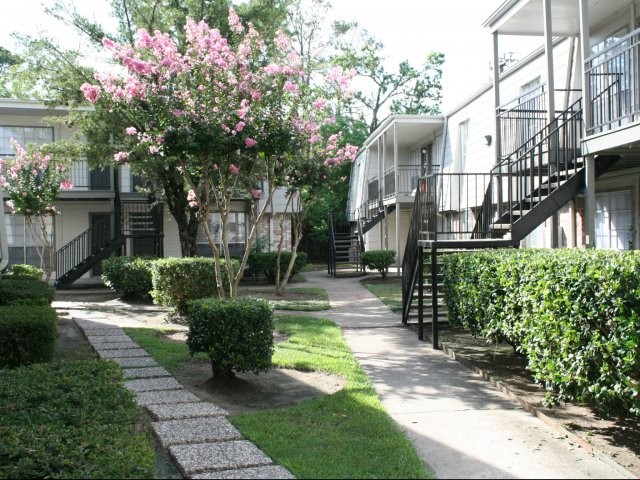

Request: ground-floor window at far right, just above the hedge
left=596, top=190, right=635, bottom=250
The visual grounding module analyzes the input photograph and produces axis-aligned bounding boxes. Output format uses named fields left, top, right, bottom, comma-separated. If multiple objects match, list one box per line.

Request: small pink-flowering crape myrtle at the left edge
left=0, top=139, right=73, bottom=281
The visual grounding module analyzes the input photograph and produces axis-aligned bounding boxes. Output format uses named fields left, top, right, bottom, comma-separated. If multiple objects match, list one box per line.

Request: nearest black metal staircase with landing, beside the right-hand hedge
left=402, top=95, right=617, bottom=348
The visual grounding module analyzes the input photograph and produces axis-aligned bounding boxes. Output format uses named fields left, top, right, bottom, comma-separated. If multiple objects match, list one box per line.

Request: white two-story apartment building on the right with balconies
left=348, top=0, right=640, bottom=267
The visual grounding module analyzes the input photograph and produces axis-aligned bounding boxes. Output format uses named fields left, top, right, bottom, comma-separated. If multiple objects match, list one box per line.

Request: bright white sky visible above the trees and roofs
left=0, top=0, right=542, bottom=112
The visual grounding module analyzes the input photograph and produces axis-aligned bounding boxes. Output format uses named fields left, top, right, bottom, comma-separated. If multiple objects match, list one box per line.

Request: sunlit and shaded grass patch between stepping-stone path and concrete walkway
left=230, top=316, right=429, bottom=478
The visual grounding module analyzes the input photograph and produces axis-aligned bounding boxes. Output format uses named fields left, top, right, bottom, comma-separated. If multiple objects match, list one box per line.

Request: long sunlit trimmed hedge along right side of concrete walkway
left=442, top=249, right=640, bottom=416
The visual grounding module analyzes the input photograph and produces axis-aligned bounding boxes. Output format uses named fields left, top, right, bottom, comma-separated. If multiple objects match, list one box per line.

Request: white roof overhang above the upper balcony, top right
left=483, top=0, right=629, bottom=37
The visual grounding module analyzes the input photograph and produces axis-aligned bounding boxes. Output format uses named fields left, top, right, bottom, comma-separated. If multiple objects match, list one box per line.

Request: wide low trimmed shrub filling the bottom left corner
left=0, top=360, right=154, bottom=478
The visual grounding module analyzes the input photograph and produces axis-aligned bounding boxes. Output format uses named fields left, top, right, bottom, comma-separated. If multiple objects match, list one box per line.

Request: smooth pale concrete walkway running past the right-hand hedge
left=304, top=272, right=625, bottom=478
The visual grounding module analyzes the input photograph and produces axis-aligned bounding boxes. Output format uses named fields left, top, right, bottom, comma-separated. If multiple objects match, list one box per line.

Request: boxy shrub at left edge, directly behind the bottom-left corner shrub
left=0, top=305, right=58, bottom=368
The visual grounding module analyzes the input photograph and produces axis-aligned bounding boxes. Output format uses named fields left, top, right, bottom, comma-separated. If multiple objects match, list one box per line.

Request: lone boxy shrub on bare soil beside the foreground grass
left=187, top=298, right=273, bottom=377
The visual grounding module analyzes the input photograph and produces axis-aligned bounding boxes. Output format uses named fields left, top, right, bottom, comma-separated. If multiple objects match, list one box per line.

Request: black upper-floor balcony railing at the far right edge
left=585, top=29, right=640, bottom=135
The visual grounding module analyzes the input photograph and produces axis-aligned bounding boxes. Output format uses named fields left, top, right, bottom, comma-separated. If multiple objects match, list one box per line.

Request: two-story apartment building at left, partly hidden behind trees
left=0, top=99, right=291, bottom=287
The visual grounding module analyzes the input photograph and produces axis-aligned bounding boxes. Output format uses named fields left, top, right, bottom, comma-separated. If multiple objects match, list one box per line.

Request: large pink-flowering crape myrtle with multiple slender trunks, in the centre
left=81, top=9, right=356, bottom=296
